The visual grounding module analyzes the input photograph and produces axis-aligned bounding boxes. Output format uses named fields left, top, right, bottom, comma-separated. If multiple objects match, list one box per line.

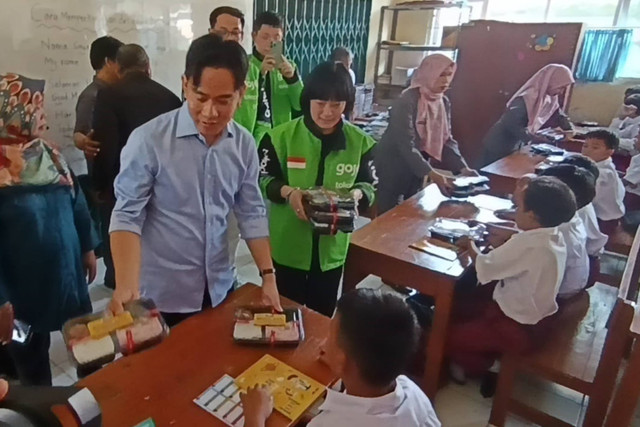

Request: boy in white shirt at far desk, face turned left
left=582, top=130, right=625, bottom=234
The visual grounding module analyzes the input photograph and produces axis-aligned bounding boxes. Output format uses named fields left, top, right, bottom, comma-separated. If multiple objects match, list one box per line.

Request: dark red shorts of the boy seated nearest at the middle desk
left=447, top=285, right=553, bottom=377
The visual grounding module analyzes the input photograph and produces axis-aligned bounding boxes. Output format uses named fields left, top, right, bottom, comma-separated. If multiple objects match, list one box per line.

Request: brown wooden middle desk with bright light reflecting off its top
left=343, top=185, right=511, bottom=398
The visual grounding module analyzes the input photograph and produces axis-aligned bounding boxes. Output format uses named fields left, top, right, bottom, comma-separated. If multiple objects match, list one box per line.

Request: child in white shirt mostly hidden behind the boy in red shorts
left=540, top=165, right=599, bottom=299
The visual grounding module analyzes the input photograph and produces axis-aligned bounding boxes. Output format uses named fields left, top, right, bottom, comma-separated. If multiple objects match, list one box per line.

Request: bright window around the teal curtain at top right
left=468, top=0, right=640, bottom=78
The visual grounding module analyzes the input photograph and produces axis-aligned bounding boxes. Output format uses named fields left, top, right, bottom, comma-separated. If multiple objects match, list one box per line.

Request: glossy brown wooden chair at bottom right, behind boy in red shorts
left=490, top=232, right=640, bottom=427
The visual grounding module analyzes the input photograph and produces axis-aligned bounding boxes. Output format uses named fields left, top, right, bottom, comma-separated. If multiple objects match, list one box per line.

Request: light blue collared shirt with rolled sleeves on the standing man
left=110, top=103, right=269, bottom=313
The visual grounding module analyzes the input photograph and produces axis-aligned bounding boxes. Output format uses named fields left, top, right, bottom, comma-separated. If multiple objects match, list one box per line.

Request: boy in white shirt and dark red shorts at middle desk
left=447, top=177, right=576, bottom=396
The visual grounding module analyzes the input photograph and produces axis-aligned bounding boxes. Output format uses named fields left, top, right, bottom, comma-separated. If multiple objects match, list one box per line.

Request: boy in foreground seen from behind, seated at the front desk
left=241, top=289, right=440, bottom=427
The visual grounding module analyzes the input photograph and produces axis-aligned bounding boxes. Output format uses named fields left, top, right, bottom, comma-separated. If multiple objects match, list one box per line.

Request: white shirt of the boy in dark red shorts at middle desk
left=476, top=227, right=567, bottom=325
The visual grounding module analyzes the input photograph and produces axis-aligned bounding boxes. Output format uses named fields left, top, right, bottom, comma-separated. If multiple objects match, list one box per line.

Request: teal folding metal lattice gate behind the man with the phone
left=253, top=0, right=371, bottom=82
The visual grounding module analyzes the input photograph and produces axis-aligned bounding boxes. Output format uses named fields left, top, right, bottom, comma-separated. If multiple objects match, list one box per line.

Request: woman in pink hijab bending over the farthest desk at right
left=480, top=64, right=575, bottom=166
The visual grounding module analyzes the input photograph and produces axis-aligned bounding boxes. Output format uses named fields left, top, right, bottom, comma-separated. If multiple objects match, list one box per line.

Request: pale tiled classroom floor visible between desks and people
left=50, top=242, right=640, bottom=427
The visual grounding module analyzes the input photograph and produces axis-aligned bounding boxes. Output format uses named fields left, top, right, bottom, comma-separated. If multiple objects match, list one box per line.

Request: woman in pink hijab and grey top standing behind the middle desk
left=375, top=54, right=476, bottom=213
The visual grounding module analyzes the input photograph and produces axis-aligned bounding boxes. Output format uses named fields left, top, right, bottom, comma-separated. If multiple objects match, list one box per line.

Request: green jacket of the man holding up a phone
left=234, top=54, right=303, bottom=142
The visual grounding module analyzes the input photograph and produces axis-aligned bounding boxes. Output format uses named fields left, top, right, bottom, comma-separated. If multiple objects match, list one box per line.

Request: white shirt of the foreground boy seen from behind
left=308, top=375, right=441, bottom=427
